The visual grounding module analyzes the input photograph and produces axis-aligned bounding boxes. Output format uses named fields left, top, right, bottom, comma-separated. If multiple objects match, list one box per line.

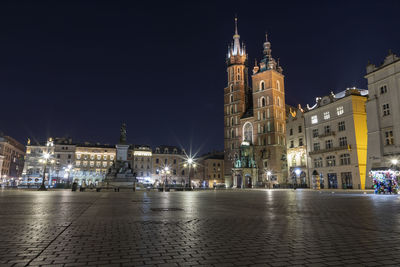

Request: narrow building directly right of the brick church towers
left=286, top=105, right=310, bottom=187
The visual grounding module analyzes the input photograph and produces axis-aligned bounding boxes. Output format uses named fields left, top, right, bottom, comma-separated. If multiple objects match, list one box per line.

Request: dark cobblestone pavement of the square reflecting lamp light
left=0, top=190, right=400, bottom=266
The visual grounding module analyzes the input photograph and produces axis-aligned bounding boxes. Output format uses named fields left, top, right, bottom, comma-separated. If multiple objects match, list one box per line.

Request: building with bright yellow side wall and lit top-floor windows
left=304, top=89, right=368, bottom=189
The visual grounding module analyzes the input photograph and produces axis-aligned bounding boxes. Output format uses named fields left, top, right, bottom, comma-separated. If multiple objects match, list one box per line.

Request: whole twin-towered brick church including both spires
left=224, top=19, right=287, bottom=188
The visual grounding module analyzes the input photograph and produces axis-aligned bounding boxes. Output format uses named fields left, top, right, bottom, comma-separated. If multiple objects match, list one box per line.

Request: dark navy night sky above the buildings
left=0, top=1, right=400, bottom=152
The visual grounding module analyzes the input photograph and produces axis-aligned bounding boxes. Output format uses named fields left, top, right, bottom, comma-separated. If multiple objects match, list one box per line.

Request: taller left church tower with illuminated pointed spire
left=224, top=18, right=251, bottom=182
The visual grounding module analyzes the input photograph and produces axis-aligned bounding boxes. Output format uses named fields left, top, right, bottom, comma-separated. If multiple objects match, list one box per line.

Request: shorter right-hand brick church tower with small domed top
left=252, top=33, right=287, bottom=183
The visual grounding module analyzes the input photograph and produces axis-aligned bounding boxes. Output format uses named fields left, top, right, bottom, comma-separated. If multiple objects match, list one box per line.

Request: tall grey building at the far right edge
left=365, top=51, right=400, bottom=187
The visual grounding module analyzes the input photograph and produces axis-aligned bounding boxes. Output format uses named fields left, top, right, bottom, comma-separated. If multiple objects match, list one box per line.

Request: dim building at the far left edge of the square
left=0, top=135, right=25, bottom=185
